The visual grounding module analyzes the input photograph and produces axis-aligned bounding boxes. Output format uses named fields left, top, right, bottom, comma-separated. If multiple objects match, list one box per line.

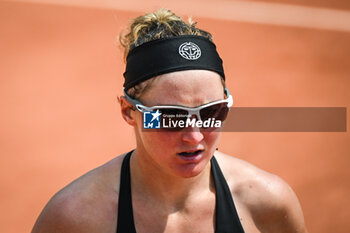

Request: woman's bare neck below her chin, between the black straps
left=130, top=149, right=214, bottom=206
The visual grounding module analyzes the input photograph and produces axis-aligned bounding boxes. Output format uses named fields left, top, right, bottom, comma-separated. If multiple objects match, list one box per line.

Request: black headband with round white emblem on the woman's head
left=124, top=35, right=225, bottom=90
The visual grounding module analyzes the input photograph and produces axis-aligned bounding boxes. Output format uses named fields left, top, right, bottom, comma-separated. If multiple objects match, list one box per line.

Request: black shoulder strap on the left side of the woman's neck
left=117, top=151, right=136, bottom=233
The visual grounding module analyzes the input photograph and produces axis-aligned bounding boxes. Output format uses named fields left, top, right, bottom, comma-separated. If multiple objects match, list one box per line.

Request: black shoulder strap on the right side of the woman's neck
left=211, top=157, right=244, bottom=233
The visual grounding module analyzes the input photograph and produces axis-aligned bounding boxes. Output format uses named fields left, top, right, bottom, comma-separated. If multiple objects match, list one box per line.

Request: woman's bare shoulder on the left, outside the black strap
left=32, top=154, right=129, bottom=233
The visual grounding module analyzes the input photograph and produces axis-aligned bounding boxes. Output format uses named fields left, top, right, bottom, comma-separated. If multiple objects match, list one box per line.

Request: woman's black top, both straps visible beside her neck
left=117, top=151, right=244, bottom=233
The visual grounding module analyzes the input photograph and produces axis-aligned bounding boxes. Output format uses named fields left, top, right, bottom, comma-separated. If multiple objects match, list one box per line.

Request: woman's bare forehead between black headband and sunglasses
left=141, top=70, right=224, bottom=107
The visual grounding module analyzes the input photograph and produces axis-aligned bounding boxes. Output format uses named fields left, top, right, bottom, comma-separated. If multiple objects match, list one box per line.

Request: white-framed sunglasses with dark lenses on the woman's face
left=124, top=88, right=233, bottom=131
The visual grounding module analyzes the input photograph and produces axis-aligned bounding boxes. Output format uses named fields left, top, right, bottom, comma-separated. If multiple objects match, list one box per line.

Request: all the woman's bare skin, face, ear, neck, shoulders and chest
left=32, top=71, right=307, bottom=233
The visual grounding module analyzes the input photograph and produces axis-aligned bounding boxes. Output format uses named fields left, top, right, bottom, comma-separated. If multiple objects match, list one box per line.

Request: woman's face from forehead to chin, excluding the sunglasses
left=129, top=70, right=224, bottom=177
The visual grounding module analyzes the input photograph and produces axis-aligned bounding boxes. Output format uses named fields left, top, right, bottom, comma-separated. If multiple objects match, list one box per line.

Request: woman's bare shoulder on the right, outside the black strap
left=215, top=152, right=307, bottom=233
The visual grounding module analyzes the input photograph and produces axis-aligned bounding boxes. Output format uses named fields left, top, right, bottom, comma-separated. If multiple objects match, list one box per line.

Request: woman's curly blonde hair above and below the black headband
left=119, top=9, right=216, bottom=98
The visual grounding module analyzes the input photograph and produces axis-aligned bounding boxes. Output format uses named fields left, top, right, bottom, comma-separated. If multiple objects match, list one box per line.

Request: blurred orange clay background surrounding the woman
left=0, top=0, right=350, bottom=233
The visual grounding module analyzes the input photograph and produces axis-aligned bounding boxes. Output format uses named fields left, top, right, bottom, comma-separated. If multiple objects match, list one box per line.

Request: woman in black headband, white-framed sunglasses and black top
left=32, top=9, right=307, bottom=233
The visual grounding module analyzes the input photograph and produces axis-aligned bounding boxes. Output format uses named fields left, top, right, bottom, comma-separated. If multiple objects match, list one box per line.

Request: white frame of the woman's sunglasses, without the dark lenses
left=123, top=88, right=233, bottom=120
